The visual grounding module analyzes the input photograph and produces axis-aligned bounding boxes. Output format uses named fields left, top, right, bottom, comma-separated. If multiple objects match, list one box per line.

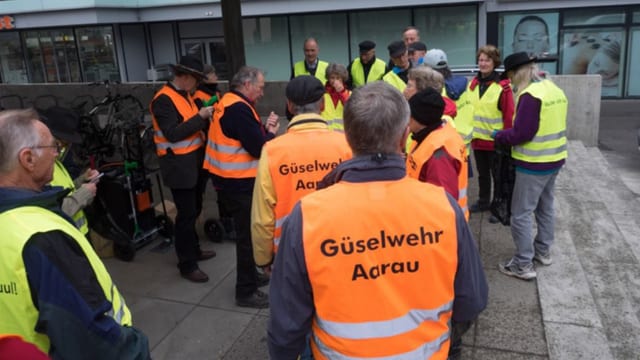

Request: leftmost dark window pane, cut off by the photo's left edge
left=0, top=32, right=29, bottom=84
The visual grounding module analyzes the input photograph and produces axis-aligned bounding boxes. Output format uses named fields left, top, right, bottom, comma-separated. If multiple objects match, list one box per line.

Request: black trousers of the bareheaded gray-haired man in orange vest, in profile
left=218, top=191, right=258, bottom=298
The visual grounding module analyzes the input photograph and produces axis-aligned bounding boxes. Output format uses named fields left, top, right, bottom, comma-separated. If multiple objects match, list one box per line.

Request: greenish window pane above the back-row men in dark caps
left=348, top=10, right=411, bottom=62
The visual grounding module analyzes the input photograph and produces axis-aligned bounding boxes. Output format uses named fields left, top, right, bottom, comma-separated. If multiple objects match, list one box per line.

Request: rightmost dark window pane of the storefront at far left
left=76, top=26, right=120, bottom=81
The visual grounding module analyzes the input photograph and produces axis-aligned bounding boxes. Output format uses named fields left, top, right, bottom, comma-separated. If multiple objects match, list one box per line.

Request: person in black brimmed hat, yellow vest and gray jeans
left=493, top=52, right=568, bottom=280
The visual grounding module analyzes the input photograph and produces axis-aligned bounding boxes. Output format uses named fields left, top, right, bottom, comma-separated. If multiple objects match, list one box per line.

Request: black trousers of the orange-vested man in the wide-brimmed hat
left=171, top=173, right=208, bottom=274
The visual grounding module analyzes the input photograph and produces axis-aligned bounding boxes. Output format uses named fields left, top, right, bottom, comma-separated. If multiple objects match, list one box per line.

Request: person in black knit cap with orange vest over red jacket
left=407, top=87, right=469, bottom=219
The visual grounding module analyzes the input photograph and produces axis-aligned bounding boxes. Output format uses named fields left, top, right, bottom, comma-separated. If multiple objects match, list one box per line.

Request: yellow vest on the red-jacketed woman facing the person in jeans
left=466, top=82, right=504, bottom=141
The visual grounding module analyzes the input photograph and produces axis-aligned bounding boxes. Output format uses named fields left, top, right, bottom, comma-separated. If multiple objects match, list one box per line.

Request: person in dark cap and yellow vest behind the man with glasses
left=42, top=107, right=99, bottom=236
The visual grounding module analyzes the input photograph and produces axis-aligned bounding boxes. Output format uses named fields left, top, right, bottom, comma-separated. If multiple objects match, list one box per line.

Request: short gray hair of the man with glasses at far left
left=0, top=109, right=41, bottom=174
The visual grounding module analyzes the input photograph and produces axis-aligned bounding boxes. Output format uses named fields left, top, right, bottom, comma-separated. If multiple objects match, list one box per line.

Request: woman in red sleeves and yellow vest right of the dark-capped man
left=320, top=63, right=351, bottom=131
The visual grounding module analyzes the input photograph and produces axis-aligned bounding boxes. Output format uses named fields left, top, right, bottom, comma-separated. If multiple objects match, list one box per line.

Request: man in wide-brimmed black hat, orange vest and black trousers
left=150, top=56, right=216, bottom=282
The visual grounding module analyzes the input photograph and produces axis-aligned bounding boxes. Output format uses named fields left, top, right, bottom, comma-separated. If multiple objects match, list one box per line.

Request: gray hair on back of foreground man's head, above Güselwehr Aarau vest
left=344, top=81, right=410, bottom=155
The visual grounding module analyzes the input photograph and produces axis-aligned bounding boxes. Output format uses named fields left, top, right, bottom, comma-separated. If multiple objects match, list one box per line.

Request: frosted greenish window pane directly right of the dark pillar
left=242, top=16, right=291, bottom=81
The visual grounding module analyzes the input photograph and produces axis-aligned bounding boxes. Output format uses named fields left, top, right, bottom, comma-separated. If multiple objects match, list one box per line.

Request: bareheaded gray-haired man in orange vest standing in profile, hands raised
left=203, top=66, right=280, bottom=308
